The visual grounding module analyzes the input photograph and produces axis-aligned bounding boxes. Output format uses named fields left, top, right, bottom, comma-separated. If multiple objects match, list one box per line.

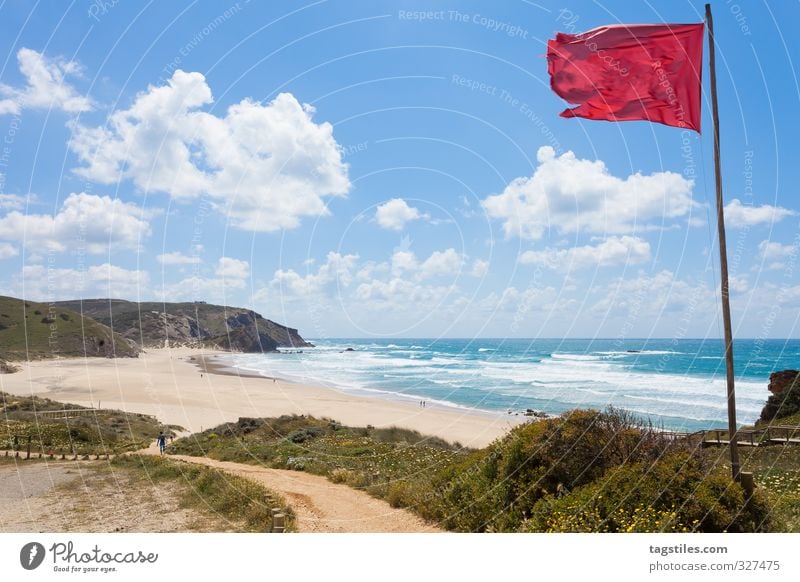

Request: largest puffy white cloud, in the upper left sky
left=70, top=70, right=350, bottom=232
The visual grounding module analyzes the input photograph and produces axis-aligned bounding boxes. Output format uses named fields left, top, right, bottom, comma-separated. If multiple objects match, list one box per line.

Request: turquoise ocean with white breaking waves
left=224, top=338, right=800, bottom=431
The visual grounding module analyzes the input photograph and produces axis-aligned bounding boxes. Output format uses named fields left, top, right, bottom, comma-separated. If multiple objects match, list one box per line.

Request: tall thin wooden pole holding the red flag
left=706, top=4, right=741, bottom=481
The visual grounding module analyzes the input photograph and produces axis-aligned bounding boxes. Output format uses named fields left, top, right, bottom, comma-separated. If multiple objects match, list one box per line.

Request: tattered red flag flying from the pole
left=547, top=23, right=703, bottom=133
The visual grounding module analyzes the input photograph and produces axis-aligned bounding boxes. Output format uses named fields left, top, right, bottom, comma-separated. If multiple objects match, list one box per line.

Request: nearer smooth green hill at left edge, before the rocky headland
left=0, top=296, right=139, bottom=362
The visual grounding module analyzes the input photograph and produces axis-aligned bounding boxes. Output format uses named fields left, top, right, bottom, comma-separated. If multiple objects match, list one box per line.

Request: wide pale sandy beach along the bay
left=0, top=348, right=524, bottom=447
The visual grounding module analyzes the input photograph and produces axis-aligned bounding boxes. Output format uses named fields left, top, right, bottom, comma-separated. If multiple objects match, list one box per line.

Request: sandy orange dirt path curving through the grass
left=142, top=447, right=442, bottom=533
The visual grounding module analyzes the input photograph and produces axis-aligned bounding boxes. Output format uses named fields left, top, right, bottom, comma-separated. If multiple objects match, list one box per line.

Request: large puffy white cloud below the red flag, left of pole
left=482, top=146, right=695, bottom=240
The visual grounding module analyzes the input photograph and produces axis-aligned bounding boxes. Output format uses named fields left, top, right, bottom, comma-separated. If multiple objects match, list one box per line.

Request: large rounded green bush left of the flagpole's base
left=427, top=409, right=673, bottom=531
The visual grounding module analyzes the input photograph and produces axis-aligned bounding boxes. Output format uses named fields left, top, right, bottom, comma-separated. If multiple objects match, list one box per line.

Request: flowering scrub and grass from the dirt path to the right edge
left=169, top=410, right=800, bottom=532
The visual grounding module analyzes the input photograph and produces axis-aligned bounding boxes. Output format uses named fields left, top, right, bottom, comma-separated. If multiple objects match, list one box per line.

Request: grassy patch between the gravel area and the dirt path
left=111, top=455, right=296, bottom=533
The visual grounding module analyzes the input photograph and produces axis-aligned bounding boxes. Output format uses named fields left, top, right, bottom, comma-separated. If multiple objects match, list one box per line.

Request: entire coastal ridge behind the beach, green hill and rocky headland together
left=0, top=296, right=312, bottom=364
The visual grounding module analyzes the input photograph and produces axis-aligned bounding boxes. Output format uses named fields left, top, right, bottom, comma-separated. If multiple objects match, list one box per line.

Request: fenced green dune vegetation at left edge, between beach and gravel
left=0, top=392, right=182, bottom=455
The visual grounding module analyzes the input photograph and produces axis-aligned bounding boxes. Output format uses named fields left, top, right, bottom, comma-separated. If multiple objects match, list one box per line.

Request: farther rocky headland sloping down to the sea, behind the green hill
left=56, top=299, right=311, bottom=352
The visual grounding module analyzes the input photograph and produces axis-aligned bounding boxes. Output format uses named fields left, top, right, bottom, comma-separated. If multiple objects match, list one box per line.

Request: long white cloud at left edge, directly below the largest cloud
left=0, top=192, right=156, bottom=254
